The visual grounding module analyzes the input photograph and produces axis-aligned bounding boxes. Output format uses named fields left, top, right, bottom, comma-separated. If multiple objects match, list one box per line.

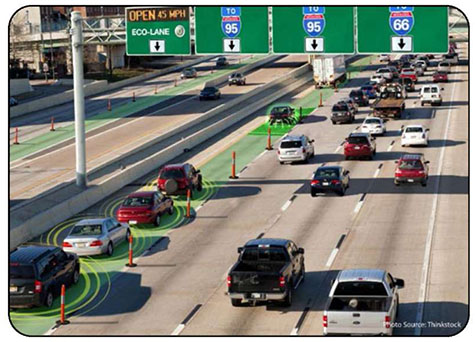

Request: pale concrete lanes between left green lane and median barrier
left=10, top=56, right=304, bottom=199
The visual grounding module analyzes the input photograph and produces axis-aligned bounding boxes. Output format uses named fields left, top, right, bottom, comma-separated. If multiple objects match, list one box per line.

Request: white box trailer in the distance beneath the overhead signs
left=312, top=55, right=346, bottom=87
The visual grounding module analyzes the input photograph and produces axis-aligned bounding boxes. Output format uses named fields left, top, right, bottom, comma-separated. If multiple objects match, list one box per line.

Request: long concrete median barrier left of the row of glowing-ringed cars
left=10, top=65, right=312, bottom=249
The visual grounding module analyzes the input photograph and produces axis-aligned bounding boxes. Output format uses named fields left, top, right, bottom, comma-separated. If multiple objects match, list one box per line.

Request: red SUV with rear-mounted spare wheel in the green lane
left=157, top=163, right=203, bottom=197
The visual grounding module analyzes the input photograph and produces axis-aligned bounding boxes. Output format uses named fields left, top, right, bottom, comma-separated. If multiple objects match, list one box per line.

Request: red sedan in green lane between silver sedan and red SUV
left=117, top=191, right=173, bottom=227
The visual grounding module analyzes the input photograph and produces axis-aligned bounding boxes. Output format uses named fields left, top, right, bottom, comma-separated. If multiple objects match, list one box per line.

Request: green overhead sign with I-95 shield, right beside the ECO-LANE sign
left=195, top=6, right=269, bottom=54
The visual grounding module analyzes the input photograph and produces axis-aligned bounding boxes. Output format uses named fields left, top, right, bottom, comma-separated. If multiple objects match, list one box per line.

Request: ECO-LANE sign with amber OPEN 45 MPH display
left=125, top=7, right=191, bottom=56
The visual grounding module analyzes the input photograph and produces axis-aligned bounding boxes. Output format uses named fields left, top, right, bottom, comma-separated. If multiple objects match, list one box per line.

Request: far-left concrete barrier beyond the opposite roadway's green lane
left=10, top=56, right=215, bottom=118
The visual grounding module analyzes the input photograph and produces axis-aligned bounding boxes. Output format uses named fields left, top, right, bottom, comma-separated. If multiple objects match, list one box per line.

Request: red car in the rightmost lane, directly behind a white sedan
left=394, top=153, right=429, bottom=186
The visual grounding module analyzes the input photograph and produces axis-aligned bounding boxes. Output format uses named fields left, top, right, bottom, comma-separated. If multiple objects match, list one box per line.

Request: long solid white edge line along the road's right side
left=414, top=66, right=458, bottom=336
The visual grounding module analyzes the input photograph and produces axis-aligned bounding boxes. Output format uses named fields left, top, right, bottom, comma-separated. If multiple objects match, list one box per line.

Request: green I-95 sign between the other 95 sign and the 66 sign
left=272, top=6, right=355, bottom=54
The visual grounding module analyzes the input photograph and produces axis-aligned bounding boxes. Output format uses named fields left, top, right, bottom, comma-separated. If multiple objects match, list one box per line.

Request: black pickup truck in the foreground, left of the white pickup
left=227, top=239, right=305, bottom=306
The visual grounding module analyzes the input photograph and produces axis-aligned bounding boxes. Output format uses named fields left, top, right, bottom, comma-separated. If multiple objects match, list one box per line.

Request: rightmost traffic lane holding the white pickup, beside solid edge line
left=304, top=60, right=468, bottom=334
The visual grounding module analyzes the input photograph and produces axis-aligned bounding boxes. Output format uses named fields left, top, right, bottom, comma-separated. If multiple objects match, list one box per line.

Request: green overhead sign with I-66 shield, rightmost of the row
left=357, top=6, right=449, bottom=53
